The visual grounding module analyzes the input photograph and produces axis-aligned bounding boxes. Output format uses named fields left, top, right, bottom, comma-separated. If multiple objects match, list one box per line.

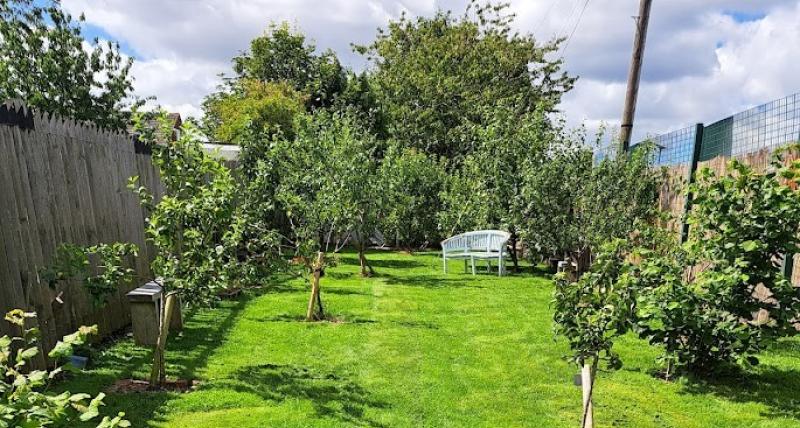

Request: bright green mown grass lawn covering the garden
left=60, top=252, right=800, bottom=428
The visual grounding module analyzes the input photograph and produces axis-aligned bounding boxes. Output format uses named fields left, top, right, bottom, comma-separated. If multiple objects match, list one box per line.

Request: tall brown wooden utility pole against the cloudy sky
left=619, top=0, right=653, bottom=152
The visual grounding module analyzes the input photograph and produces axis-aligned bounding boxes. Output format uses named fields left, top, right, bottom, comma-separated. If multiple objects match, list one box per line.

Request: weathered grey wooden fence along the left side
left=0, top=103, right=163, bottom=358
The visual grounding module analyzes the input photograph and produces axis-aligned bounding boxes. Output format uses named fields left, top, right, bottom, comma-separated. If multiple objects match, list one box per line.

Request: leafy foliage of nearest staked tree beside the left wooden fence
left=130, top=110, right=282, bottom=304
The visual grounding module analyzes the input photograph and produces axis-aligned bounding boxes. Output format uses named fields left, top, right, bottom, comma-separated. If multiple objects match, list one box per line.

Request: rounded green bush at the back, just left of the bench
left=377, top=145, right=444, bottom=249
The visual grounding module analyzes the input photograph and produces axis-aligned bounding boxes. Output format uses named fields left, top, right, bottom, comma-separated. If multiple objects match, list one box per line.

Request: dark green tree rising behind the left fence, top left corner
left=0, top=0, right=133, bottom=129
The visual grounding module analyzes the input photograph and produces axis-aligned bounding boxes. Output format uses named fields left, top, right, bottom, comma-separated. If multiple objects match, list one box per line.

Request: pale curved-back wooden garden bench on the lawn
left=442, top=230, right=511, bottom=276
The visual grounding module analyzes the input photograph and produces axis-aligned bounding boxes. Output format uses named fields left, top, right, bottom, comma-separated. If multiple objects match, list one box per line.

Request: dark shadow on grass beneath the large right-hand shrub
left=686, top=366, right=800, bottom=419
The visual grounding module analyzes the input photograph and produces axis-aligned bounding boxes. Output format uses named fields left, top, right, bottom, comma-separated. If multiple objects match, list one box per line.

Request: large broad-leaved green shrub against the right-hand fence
left=638, top=148, right=800, bottom=373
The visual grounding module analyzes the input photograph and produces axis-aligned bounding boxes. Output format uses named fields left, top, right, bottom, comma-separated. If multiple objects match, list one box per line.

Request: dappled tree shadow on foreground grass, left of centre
left=208, top=364, right=388, bottom=427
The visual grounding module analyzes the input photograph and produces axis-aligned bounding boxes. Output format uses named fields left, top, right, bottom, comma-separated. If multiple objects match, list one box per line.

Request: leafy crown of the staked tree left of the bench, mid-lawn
left=276, top=112, right=381, bottom=274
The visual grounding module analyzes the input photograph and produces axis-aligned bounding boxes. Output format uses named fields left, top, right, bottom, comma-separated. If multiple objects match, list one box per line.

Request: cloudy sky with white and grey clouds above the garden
left=62, top=0, right=800, bottom=141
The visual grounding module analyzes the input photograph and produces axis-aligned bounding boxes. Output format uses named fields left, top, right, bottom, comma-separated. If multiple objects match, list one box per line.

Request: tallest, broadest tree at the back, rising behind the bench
left=358, top=1, right=575, bottom=164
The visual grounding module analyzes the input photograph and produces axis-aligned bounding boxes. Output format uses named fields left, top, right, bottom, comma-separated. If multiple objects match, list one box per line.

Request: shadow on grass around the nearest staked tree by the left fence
left=59, top=293, right=253, bottom=428
